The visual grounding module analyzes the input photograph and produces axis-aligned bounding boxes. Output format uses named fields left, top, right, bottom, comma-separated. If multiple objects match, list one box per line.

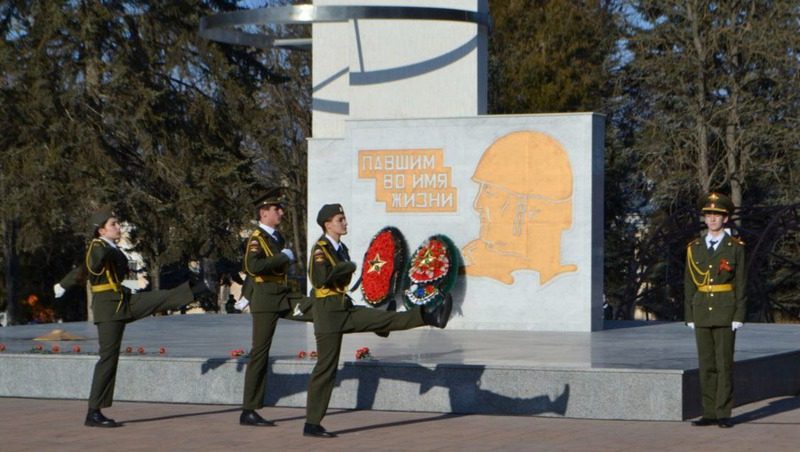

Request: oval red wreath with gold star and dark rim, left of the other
left=361, top=227, right=406, bottom=306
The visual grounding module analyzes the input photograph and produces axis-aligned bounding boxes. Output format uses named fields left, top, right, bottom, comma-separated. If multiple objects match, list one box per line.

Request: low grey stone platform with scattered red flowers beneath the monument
left=0, top=314, right=800, bottom=421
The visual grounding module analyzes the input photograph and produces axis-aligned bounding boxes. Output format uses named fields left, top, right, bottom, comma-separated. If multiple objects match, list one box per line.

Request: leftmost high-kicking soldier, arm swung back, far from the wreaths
left=53, top=209, right=194, bottom=427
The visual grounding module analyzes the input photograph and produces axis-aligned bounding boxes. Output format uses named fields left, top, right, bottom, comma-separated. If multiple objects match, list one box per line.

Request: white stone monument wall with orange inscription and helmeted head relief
left=308, top=113, right=604, bottom=331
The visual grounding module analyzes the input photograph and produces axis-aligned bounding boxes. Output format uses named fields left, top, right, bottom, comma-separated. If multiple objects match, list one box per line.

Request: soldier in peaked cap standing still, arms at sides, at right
left=684, top=193, right=747, bottom=428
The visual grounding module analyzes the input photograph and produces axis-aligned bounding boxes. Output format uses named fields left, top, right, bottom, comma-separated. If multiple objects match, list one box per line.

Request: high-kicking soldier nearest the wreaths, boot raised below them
left=303, top=204, right=452, bottom=438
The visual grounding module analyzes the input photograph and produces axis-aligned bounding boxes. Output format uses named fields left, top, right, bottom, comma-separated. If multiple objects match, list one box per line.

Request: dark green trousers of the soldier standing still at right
left=695, top=326, right=736, bottom=419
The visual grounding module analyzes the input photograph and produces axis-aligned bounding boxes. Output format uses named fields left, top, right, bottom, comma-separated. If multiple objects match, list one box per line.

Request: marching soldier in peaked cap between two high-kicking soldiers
left=239, top=190, right=310, bottom=427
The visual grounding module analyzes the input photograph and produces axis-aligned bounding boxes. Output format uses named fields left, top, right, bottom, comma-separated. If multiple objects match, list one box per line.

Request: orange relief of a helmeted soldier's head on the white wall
left=461, top=131, right=578, bottom=284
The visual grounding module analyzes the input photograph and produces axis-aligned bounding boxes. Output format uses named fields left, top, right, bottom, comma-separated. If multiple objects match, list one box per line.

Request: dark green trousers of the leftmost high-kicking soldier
left=89, top=284, right=193, bottom=409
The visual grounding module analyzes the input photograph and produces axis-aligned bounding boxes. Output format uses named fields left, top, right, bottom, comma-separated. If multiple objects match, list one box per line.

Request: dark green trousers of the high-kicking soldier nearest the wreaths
left=306, top=307, right=425, bottom=425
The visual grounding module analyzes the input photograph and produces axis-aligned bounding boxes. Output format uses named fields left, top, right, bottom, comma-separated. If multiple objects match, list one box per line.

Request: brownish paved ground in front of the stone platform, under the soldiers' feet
left=0, top=396, right=800, bottom=452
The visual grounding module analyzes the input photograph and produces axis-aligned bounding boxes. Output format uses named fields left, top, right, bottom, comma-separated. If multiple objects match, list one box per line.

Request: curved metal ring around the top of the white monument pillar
left=199, top=5, right=490, bottom=50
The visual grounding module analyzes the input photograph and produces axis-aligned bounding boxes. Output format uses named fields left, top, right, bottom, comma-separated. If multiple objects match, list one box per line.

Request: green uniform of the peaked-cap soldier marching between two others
left=242, top=227, right=311, bottom=410
